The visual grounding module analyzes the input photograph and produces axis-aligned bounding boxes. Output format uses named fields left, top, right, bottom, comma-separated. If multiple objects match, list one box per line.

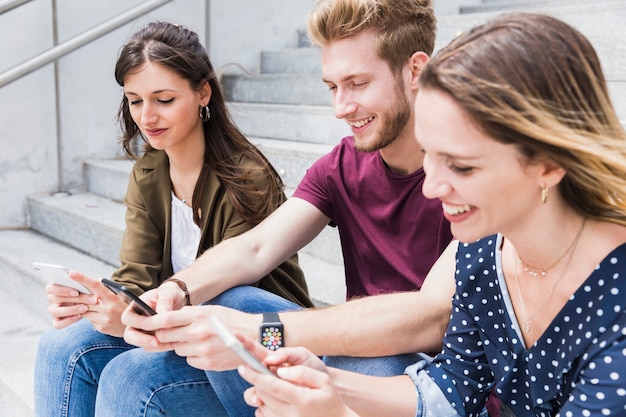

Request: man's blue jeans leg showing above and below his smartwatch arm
left=206, top=286, right=302, bottom=417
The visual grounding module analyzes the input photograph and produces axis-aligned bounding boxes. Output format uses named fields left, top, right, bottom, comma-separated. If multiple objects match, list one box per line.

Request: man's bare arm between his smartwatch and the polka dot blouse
left=281, top=242, right=457, bottom=357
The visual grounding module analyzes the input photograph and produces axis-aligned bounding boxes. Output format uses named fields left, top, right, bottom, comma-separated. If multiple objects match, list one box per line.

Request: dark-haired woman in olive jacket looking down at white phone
left=35, top=22, right=312, bottom=417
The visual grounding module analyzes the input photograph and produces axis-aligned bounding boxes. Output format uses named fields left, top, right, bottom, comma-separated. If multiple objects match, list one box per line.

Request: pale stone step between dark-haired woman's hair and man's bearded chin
left=228, top=102, right=351, bottom=145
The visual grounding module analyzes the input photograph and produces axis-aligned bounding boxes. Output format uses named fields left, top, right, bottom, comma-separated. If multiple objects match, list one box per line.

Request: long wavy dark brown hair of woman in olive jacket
left=115, top=22, right=284, bottom=225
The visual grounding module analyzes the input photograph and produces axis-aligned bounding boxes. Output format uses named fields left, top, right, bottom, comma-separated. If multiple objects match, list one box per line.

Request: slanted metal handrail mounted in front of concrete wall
left=0, top=0, right=172, bottom=88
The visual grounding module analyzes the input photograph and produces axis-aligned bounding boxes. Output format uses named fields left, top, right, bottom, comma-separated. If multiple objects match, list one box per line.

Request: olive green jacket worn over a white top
left=113, top=151, right=312, bottom=307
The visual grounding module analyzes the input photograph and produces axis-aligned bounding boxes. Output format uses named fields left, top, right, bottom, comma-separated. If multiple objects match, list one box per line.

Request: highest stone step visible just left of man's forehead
left=261, top=47, right=322, bottom=75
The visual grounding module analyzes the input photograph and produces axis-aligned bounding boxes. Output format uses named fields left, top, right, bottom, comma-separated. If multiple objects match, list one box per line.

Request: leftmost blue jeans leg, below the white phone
left=34, top=320, right=134, bottom=417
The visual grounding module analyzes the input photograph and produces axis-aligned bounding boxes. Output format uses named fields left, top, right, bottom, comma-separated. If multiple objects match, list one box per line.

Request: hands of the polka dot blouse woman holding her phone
left=239, top=340, right=356, bottom=417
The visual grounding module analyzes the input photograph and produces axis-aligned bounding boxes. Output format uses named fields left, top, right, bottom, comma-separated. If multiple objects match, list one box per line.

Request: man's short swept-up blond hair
left=307, top=0, right=436, bottom=73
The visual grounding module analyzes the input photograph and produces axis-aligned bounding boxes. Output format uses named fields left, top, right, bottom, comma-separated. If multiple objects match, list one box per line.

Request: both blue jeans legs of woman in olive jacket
left=35, top=320, right=226, bottom=417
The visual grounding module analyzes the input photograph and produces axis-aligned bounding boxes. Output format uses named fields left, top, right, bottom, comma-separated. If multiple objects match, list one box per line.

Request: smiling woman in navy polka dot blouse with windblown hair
left=234, top=13, right=626, bottom=417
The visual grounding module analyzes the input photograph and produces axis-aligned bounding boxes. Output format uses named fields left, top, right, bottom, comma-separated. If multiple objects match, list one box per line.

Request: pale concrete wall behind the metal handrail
left=0, top=0, right=207, bottom=229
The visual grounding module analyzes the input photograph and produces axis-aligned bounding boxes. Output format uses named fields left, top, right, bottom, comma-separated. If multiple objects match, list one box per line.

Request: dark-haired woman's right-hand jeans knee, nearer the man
left=96, top=349, right=227, bottom=417
